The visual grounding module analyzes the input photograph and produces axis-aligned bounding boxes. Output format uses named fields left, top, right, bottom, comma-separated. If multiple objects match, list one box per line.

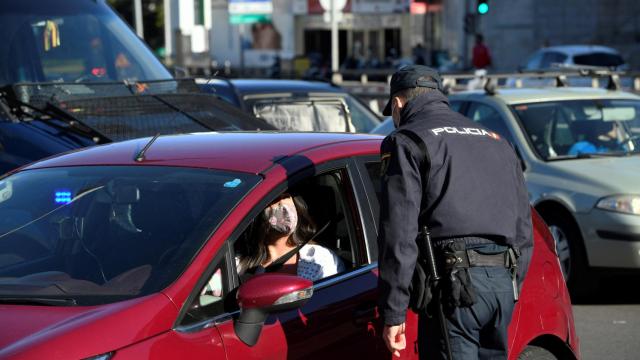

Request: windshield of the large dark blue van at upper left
left=0, top=0, right=171, bottom=84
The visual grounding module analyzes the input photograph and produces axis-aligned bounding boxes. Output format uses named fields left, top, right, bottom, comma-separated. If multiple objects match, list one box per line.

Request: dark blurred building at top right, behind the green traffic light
left=470, top=0, right=640, bottom=71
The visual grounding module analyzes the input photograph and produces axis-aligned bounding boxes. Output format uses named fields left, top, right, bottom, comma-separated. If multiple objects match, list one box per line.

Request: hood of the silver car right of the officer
left=543, top=155, right=640, bottom=196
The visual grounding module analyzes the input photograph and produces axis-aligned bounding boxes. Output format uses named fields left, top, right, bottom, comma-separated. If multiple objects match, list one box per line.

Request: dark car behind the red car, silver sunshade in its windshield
left=197, top=79, right=380, bottom=133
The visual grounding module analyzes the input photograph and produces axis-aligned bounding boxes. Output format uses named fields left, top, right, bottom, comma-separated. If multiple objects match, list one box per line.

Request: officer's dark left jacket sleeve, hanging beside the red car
left=378, top=134, right=426, bottom=325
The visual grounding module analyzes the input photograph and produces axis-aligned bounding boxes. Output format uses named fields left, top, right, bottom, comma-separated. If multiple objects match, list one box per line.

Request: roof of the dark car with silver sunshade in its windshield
left=231, top=79, right=345, bottom=94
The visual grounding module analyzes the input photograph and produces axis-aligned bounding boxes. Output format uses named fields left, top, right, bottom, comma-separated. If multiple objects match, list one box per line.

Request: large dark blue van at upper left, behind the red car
left=0, top=0, right=273, bottom=174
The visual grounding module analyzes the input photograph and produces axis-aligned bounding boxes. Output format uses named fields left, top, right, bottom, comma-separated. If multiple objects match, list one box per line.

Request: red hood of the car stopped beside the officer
left=0, top=293, right=177, bottom=359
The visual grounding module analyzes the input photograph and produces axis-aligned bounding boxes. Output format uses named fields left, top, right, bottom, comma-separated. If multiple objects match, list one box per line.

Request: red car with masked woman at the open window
left=0, top=133, right=580, bottom=360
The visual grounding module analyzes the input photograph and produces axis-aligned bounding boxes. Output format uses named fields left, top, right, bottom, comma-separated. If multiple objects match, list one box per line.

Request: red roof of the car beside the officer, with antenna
left=26, top=132, right=383, bottom=174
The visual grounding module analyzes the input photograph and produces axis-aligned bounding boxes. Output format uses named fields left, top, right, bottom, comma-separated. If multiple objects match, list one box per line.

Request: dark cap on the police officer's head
left=382, top=65, right=442, bottom=116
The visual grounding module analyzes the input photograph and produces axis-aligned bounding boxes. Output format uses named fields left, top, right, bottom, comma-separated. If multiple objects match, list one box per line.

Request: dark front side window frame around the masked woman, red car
left=173, top=158, right=377, bottom=332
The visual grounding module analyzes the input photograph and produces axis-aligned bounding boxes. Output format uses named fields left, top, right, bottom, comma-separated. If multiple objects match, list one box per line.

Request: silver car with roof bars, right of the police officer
left=374, top=88, right=640, bottom=297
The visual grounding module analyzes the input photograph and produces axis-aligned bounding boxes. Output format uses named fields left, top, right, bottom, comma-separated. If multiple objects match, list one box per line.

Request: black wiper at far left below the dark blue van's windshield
left=0, top=86, right=111, bottom=144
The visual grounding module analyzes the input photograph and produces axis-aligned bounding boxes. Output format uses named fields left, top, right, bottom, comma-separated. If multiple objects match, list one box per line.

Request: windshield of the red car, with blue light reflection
left=0, top=166, right=259, bottom=305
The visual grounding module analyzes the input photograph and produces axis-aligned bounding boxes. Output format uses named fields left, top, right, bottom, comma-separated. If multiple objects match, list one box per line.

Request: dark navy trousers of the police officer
left=418, top=267, right=515, bottom=360
